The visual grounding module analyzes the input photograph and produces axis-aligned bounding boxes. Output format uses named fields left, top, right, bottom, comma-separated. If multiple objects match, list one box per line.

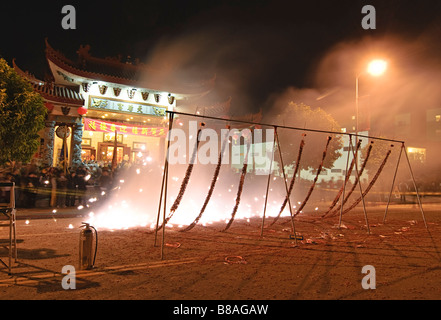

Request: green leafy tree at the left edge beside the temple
left=0, top=59, right=47, bottom=166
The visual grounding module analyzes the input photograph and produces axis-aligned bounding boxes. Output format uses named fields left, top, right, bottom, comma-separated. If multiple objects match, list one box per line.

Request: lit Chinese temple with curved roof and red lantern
left=13, top=40, right=229, bottom=167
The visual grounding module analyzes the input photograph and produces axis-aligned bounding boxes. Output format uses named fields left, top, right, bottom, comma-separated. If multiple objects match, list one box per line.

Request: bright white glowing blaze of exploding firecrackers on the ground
left=87, top=167, right=295, bottom=230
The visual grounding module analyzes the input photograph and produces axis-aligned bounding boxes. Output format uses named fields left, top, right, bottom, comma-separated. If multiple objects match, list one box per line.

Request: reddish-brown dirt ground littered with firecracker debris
left=0, top=204, right=441, bottom=300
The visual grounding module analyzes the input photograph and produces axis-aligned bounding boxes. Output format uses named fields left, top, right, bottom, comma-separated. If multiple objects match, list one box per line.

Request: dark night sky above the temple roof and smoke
left=0, top=0, right=441, bottom=114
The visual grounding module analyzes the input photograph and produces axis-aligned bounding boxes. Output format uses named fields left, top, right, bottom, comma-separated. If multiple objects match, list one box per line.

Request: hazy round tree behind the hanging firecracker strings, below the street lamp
left=262, top=101, right=343, bottom=170
